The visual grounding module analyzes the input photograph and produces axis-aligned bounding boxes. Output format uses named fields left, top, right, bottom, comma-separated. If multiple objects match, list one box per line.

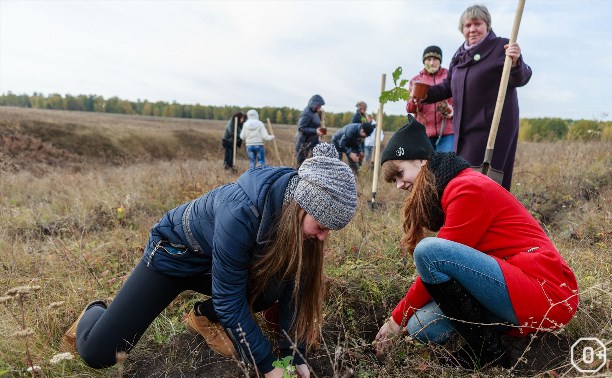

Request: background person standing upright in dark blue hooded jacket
left=295, top=95, right=325, bottom=167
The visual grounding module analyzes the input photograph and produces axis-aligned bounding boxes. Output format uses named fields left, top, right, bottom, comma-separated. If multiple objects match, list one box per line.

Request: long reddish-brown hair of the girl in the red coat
left=382, top=160, right=443, bottom=254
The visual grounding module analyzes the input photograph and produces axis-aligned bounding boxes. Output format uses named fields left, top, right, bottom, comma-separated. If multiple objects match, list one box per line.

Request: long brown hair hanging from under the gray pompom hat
left=249, top=200, right=324, bottom=345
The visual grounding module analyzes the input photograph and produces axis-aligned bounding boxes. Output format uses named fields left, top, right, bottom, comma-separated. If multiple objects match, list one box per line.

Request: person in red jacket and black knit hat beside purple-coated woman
left=406, top=46, right=455, bottom=152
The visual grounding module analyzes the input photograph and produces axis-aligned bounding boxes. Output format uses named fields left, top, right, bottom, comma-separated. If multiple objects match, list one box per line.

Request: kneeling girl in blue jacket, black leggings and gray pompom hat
left=62, top=143, right=357, bottom=377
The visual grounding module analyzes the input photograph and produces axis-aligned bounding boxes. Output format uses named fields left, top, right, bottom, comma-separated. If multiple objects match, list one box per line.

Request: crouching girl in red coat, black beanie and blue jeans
left=376, top=117, right=578, bottom=369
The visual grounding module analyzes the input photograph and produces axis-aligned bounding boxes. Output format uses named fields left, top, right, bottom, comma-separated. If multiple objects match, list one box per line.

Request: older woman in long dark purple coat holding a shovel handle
left=411, top=5, right=531, bottom=190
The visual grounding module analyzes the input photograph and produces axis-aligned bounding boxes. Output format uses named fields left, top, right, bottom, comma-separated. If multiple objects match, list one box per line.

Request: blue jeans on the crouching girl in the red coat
left=406, top=238, right=518, bottom=344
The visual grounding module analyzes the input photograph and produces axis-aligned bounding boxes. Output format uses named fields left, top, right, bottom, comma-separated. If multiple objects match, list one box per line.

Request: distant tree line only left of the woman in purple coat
left=0, top=92, right=406, bottom=130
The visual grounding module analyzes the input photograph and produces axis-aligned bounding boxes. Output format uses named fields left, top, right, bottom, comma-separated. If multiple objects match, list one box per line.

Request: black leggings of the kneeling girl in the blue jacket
left=76, top=260, right=284, bottom=369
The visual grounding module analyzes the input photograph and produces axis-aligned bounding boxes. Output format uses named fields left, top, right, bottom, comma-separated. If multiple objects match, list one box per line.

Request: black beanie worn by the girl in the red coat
left=381, top=115, right=434, bottom=164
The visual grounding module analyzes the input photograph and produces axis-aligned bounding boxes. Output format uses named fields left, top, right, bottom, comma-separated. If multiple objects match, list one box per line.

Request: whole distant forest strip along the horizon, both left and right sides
left=0, top=92, right=612, bottom=141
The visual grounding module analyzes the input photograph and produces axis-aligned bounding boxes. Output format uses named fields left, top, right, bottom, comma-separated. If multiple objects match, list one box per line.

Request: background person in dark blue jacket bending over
left=332, top=122, right=374, bottom=172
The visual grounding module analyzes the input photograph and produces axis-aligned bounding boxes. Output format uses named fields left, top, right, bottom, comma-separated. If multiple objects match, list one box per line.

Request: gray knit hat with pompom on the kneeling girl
left=293, top=143, right=357, bottom=230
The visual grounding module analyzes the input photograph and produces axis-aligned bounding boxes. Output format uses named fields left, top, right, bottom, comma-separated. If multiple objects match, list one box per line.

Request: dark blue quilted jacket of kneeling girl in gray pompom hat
left=143, top=166, right=302, bottom=373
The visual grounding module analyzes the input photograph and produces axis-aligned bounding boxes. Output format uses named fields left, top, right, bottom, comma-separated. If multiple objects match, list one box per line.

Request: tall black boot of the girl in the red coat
left=423, top=279, right=510, bottom=370
